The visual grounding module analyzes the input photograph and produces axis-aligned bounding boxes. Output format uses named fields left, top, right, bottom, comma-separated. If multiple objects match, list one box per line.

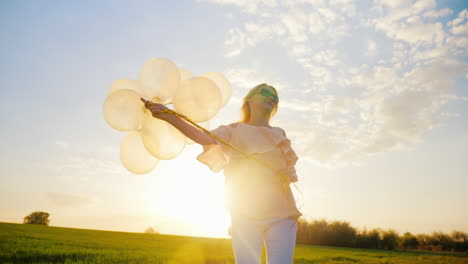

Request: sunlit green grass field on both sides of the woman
left=0, top=223, right=468, bottom=264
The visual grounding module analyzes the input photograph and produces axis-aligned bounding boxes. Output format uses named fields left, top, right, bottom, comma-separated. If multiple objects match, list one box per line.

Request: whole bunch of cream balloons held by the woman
left=103, top=58, right=232, bottom=174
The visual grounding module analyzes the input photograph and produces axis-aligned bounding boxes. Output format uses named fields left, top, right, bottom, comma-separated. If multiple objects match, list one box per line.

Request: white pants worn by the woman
left=231, top=216, right=297, bottom=264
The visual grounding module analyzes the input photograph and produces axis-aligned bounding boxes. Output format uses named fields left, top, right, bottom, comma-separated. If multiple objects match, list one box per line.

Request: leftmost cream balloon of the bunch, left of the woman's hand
left=103, top=89, right=144, bottom=131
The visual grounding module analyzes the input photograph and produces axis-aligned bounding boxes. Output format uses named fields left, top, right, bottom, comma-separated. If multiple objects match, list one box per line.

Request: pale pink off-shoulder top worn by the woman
left=197, top=123, right=302, bottom=219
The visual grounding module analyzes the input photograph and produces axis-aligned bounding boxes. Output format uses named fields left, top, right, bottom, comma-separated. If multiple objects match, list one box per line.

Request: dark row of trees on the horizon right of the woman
left=297, top=219, right=468, bottom=252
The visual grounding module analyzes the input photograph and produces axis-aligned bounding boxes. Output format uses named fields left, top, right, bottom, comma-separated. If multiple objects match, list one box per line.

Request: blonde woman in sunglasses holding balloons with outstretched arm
left=142, top=84, right=302, bottom=264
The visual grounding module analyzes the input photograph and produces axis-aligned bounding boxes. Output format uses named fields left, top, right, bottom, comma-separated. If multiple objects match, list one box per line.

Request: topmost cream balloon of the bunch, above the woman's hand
left=138, top=58, right=180, bottom=102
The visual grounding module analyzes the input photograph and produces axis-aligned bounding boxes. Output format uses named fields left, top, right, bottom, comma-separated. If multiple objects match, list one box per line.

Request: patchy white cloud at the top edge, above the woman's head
left=212, top=0, right=354, bottom=57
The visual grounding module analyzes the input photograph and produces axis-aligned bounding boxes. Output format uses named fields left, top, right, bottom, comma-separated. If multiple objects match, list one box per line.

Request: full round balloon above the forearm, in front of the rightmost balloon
left=174, top=77, right=221, bottom=123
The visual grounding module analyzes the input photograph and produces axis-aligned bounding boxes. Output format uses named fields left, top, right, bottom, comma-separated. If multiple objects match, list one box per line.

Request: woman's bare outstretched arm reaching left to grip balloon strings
left=141, top=98, right=216, bottom=145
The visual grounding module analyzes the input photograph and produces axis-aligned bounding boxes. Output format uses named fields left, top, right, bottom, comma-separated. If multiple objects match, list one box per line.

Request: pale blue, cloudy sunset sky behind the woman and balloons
left=0, top=0, right=468, bottom=237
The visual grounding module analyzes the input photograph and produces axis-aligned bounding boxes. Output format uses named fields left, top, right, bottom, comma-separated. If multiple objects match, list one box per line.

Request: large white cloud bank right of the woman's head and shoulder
left=287, top=58, right=467, bottom=166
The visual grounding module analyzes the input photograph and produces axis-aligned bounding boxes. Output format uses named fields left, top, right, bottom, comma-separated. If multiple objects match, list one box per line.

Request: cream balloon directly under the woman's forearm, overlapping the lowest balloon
left=141, top=113, right=187, bottom=160
